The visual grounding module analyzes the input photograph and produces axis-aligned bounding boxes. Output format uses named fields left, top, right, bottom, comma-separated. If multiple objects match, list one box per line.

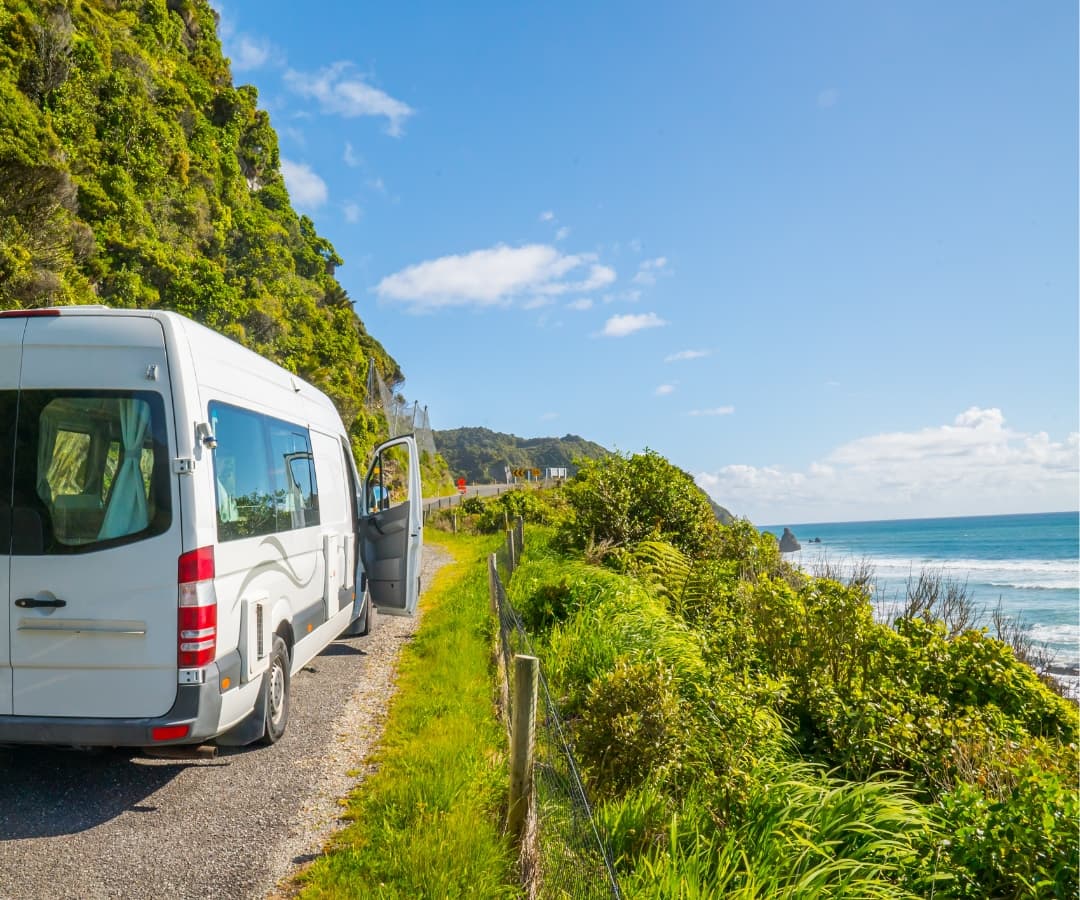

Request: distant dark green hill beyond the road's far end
left=435, top=428, right=608, bottom=482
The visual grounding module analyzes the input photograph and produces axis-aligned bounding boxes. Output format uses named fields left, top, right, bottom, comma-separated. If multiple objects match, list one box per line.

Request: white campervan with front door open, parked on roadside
left=0, top=307, right=422, bottom=747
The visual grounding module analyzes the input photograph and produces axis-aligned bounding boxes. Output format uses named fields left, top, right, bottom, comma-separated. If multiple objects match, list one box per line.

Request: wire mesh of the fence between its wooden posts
left=488, top=519, right=622, bottom=900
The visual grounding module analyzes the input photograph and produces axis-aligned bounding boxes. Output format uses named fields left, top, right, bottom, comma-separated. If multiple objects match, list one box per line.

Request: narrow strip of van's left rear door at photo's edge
left=0, top=318, right=26, bottom=715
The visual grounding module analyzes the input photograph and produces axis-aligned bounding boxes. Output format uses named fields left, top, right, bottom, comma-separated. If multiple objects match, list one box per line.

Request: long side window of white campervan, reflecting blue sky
left=210, top=402, right=319, bottom=540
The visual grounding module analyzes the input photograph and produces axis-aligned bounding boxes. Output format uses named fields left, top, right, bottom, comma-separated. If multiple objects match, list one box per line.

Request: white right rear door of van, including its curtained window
left=6, top=314, right=181, bottom=717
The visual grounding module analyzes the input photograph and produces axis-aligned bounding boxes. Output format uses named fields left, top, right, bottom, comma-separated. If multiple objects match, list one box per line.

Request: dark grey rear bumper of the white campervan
left=0, top=657, right=239, bottom=747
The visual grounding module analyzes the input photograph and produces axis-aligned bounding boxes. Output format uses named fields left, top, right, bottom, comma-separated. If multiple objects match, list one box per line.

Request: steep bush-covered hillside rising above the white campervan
left=0, top=0, right=401, bottom=457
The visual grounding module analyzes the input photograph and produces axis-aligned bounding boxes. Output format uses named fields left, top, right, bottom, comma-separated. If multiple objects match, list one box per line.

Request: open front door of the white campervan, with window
left=360, top=434, right=423, bottom=616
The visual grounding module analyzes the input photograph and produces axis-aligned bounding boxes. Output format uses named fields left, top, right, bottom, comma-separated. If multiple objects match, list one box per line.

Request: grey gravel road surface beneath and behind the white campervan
left=0, top=546, right=448, bottom=900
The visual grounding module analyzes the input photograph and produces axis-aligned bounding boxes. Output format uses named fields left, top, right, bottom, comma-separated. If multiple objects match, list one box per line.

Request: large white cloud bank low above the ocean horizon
left=698, top=406, right=1080, bottom=524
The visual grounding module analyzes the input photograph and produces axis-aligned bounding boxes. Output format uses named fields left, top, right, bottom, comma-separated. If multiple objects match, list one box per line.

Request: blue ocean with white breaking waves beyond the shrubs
left=762, top=512, right=1080, bottom=667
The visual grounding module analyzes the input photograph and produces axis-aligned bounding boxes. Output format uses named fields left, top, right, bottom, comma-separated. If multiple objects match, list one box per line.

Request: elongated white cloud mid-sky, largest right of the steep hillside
left=374, top=244, right=616, bottom=310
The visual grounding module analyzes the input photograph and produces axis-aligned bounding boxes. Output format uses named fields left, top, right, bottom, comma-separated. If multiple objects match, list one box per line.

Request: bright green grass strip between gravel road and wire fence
left=300, top=529, right=519, bottom=900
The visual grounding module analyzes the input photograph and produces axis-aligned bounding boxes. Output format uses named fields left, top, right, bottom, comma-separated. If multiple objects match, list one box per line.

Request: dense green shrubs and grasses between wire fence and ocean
left=451, top=454, right=1080, bottom=898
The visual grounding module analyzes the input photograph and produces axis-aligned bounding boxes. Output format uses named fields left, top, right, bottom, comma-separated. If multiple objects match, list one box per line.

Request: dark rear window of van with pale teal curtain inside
left=12, top=390, right=172, bottom=555
